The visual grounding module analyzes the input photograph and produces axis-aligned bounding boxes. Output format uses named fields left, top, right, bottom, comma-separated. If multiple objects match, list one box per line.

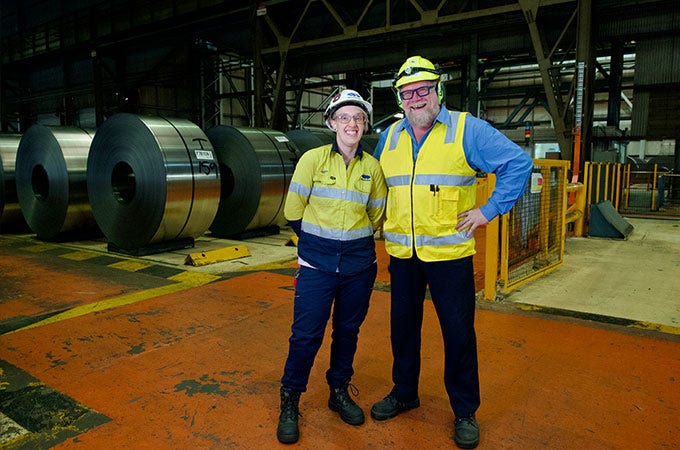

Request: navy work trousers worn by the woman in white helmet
left=281, top=263, right=378, bottom=392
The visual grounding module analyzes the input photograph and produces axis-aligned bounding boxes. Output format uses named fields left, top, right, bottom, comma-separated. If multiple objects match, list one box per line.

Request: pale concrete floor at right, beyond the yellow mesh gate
left=506, top=218, right=680, bottom=334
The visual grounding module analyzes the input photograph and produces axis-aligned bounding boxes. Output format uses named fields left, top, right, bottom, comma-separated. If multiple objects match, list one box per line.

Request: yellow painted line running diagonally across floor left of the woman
left=5, top=272, right=220, bottom=334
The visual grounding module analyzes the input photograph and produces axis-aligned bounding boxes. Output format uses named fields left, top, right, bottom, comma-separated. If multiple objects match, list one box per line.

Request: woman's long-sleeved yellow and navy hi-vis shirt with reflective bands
left=284, top=145, right=387, bottom=274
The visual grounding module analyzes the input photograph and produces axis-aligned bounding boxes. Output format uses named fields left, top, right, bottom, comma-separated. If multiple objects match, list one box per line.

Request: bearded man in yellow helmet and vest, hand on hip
left=371, top=56, right=533, bottom=448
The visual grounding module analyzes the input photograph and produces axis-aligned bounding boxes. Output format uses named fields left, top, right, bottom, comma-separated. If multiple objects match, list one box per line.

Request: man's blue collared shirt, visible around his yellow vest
left=373, top=106, right=533, bottom=220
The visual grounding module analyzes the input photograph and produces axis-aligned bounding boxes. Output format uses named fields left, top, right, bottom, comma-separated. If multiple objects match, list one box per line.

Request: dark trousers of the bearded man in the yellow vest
left=390, top=256, right=480, bottom=417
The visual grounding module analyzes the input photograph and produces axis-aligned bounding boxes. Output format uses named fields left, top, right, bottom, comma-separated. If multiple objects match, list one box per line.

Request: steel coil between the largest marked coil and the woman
left=206, top=125, right=298, bottom=237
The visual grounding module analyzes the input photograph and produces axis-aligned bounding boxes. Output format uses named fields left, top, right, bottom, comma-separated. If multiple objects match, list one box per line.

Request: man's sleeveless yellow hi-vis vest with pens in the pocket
left=380, top=111, right=477, bottom=261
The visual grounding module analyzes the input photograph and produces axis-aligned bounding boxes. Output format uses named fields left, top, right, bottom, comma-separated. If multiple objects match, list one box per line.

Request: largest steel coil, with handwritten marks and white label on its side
left=87, top=113, right=220, bottom=253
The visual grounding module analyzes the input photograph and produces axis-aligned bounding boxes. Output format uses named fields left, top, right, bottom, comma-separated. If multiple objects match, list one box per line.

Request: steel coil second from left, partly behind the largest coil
left=16, top=124, right=96, bottom=240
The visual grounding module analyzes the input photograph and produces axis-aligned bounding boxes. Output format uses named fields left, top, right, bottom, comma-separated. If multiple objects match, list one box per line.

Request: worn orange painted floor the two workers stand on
left=0, top=238, right=680, bottom=450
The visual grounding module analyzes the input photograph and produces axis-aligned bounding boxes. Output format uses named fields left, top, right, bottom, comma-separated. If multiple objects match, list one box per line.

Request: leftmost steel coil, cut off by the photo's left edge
left=0, top=133, right=28, bottom=232
